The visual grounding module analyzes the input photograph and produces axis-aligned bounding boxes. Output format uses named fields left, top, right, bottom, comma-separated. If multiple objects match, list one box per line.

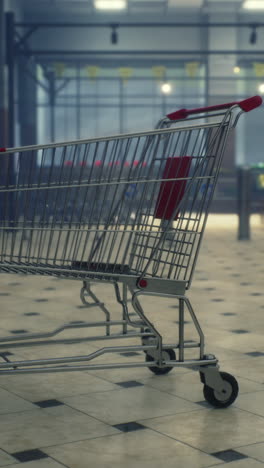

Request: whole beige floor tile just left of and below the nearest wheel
left=62, top=387, right=197, bottom=424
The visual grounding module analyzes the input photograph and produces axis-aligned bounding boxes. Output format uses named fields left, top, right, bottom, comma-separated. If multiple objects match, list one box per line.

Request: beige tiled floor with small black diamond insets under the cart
left=0, top=216, right=264, bottom=468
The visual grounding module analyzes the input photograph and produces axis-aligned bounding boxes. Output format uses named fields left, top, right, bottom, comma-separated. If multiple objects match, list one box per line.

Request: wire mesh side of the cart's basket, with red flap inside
left=0, top=120, right=231, bottom=279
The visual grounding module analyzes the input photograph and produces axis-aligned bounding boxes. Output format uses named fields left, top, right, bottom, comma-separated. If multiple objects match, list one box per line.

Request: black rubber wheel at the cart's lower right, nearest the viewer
left=203, top=372, right=239, bottom=408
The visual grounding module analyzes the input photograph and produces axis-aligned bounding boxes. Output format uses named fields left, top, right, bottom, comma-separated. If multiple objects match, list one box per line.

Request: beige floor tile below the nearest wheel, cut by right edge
left=138, top=407, right=264, bottom=453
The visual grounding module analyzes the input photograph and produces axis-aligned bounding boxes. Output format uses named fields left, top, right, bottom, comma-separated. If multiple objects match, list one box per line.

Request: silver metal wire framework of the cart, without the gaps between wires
left=0, top=97, right=262, bottom=407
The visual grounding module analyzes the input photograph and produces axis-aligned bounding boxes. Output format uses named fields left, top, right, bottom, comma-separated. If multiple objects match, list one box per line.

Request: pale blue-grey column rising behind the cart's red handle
left=207, top=0, right=239, bottom=213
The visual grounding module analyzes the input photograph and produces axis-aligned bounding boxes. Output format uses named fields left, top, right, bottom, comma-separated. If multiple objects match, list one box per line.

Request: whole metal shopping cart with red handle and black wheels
left=0, top=96, right=262, bottom=407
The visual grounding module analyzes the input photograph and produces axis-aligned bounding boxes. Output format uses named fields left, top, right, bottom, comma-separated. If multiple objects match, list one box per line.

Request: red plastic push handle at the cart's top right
left=167, top=96, right=262, bottom=120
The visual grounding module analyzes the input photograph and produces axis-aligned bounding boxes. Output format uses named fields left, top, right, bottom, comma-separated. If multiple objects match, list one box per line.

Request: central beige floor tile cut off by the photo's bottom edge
left=46, top=430, right=223, bottom=468
